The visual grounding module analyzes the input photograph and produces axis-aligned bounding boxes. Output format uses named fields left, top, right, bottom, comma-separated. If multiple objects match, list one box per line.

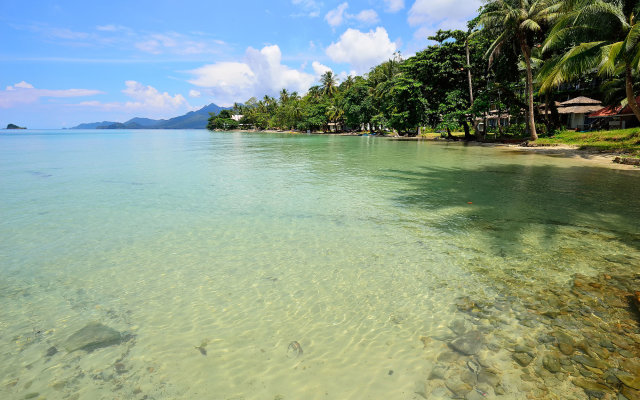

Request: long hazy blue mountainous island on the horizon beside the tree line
left=71, top=103, right=228, bottom=129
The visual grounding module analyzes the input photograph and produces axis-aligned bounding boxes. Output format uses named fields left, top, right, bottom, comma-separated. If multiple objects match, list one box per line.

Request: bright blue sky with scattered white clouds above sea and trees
left=0, top=0, right=481, bottom=129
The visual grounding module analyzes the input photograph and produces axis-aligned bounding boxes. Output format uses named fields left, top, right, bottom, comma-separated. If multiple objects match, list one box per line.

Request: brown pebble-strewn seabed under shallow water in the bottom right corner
left=416, top=273, right=640, bottom=400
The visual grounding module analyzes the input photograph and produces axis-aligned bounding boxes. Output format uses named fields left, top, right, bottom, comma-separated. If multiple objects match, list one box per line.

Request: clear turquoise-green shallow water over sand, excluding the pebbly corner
left=0, top=131, right=640, bottom=399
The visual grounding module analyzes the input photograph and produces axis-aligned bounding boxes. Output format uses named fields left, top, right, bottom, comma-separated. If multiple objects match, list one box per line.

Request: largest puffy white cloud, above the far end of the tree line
left=189, top=45, right=315, bottom=106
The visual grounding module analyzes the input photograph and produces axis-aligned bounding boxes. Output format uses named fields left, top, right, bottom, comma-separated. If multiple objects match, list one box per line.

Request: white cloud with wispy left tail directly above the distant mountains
left=77, top=81, right=193, bottom=118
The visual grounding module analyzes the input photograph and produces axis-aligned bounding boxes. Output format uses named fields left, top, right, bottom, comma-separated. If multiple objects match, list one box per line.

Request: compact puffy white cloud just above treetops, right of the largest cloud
left=326, top=27, right=397, bottom=73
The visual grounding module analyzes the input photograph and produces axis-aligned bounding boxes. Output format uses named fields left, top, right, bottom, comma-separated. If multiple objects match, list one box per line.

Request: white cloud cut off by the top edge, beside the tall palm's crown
left=409, top=0, right=482, bottom=27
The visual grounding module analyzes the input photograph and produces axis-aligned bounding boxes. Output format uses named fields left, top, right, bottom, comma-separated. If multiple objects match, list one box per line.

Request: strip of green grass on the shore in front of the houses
left=535, top=128, right=640, bottom=156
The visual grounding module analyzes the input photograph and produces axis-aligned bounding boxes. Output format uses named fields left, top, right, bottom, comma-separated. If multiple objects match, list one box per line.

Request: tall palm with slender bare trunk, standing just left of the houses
left=480, top=0, right=560, bottom=140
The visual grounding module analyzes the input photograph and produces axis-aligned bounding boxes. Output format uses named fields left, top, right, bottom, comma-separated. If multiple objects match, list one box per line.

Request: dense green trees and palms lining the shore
left=208, top=0, right=640, bottom=140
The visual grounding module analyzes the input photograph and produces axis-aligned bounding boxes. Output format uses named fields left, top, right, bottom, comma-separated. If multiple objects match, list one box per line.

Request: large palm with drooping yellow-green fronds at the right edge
left=542, top=0, right=640, bottom=121
